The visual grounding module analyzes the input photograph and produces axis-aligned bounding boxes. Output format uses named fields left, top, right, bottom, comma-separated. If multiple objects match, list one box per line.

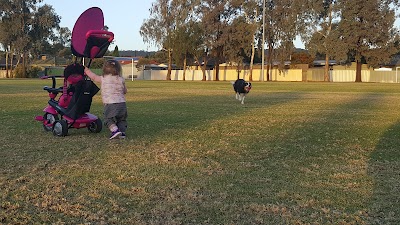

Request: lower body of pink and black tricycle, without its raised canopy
left=35, top=64, right=102, bottom=136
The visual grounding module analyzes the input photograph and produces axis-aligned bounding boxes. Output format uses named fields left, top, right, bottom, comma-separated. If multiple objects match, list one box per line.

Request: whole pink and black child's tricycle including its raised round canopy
left=35, top=7, right=114, bottom=136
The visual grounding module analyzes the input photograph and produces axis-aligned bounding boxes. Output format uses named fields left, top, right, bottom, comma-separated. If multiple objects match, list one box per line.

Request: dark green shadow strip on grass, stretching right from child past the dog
left=127, top=93, right=302, bottom=139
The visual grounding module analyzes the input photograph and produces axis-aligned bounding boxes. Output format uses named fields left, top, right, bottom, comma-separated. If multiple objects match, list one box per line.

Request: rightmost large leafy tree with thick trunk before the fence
left=336, top=0, right=398, bottom=82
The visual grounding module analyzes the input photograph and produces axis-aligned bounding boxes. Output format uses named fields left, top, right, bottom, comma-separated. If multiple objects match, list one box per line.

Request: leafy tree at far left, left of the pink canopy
left=0, top=0, right=60, bottom=76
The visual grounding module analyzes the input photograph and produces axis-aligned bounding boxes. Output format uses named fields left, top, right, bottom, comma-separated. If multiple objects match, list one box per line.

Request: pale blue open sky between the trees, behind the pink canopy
left=42, top=0, right=158, bottom=51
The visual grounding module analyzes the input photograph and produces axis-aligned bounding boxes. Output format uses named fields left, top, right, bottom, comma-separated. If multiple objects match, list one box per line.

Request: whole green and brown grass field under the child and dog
left=0, top=80, right=400, bottom=224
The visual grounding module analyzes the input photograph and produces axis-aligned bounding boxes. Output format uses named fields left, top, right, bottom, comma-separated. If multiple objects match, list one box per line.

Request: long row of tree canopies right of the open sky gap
left=141, top=0, right=399, bottom=81
